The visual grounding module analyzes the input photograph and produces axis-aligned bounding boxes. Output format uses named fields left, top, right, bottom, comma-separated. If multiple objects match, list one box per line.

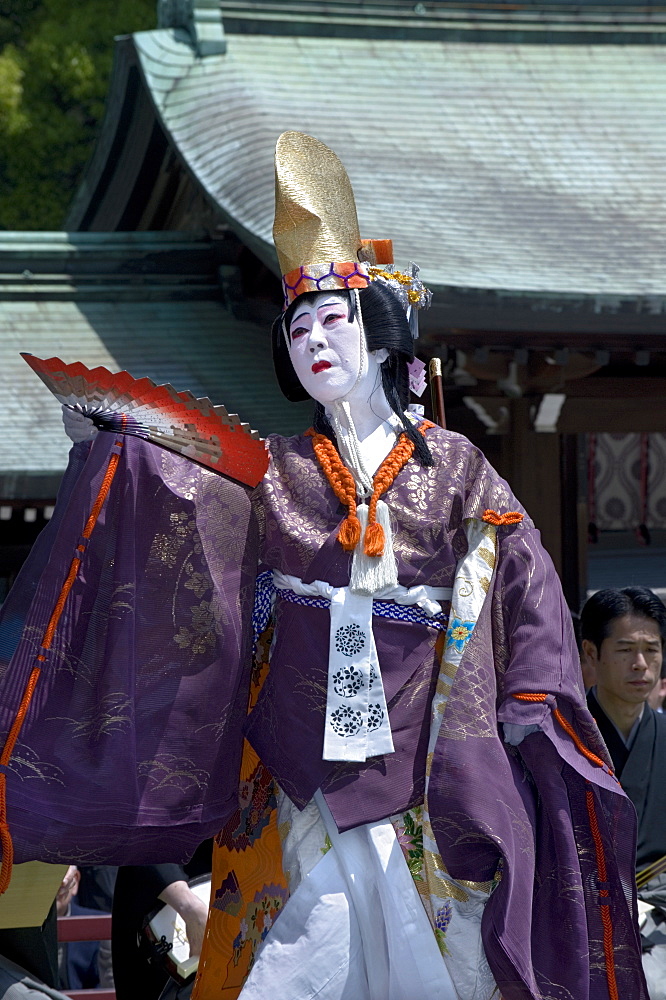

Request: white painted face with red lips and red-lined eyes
left=288, top=292, right=388, bottom=405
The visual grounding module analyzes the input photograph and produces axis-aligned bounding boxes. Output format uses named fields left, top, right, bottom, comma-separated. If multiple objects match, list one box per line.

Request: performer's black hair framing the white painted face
left=272, top=281, right=432, bottom=466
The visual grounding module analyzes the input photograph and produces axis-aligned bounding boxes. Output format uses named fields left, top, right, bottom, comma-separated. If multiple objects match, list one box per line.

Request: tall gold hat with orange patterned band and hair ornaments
left=273, top=132, right=431, bottom=308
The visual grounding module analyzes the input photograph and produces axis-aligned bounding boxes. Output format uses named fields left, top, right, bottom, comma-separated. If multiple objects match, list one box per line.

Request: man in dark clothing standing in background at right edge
left=581, top=587, right=666, bottom=1000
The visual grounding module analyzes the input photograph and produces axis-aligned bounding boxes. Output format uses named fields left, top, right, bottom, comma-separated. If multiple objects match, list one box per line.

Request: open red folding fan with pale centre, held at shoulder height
left=22, top=354, right=268, bottom=486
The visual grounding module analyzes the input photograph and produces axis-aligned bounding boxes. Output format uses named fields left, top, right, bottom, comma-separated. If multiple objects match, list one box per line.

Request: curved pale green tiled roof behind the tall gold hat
left=126, top=30, right=666, bottom=297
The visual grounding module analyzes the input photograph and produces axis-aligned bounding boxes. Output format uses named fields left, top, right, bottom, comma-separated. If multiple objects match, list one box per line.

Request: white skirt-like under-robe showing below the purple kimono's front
left=241, top=792, right=457, bottom=1000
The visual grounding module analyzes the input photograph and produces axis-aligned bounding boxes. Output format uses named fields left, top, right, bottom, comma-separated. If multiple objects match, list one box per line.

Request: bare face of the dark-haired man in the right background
left=583, top=614, right=662, bottom=705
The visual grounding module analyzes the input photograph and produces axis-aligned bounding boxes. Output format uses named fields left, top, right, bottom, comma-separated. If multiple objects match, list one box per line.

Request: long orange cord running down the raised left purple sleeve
left=0, top=434, right=125, bottom=896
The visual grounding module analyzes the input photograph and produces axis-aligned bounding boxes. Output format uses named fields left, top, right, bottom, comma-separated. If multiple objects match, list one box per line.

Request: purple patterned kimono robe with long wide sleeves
left=0, top=428, right=646, bottom=1000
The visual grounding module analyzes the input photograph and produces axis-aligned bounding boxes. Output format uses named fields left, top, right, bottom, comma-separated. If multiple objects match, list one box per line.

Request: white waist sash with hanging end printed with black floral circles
left=273, top=571, right=451, bottom=763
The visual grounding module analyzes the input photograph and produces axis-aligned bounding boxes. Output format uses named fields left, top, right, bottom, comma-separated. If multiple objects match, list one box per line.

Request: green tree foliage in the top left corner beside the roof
left=0, top=0, right=157, bottom=229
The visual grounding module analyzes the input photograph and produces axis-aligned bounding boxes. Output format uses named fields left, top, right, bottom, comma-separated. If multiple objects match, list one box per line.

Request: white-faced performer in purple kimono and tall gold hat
left=0, top=132, right=646, bottom=1000
